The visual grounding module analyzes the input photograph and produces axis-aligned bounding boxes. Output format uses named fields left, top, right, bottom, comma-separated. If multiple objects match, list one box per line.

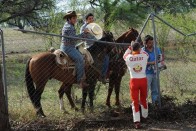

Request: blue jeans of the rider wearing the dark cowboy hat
left=60, top=44, right=84, bottom=82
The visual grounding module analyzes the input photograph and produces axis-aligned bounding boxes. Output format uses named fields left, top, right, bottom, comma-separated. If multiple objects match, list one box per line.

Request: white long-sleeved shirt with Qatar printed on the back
left=123, top=48, right=148, bottom=78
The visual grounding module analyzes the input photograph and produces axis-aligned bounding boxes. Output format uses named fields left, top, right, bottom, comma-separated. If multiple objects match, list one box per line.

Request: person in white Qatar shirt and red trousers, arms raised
left=123, top=42, right=148, bottom=129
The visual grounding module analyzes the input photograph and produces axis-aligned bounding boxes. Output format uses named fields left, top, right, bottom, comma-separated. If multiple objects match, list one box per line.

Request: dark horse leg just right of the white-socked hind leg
left=64, top=84, right=78, bottom=111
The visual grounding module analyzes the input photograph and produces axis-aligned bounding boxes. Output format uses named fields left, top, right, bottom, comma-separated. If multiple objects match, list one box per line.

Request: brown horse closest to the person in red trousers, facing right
left=106, top=28, right=139, bottom=107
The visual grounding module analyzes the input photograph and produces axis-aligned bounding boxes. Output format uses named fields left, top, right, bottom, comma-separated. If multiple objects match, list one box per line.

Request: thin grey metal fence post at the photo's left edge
left=0, top=29, right=8, bottom=113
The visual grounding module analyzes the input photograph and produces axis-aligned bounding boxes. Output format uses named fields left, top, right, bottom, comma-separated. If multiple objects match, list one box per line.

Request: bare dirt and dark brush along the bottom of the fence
left=12, top=96, right=196, bottom=131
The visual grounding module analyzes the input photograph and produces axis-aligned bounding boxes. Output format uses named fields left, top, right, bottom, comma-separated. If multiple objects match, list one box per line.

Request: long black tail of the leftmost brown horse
left=25, top=59, right=35, bottom=104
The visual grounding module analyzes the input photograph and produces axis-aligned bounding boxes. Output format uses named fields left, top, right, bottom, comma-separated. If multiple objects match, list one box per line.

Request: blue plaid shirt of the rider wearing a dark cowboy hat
left=62, top=22, right=86, bottom=46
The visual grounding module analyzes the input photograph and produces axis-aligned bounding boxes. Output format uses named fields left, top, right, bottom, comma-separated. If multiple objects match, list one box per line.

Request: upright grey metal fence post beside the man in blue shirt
left=151, top=13, right=161, bottom=108
